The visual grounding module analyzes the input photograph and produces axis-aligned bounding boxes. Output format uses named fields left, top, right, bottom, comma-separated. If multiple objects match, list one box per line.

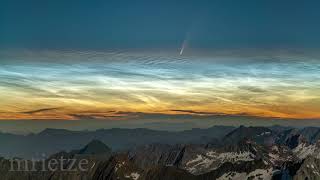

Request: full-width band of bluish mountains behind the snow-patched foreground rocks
left=0, top=126, right=320, bottom=158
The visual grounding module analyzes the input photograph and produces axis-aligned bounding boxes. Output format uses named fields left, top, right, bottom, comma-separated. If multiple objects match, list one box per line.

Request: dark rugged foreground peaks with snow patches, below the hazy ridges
left=0, top=127, right=320, bottom=180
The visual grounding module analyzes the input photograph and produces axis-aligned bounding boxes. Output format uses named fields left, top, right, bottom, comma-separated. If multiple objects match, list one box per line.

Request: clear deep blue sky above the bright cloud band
left=0, top=0, right=320, bottom=49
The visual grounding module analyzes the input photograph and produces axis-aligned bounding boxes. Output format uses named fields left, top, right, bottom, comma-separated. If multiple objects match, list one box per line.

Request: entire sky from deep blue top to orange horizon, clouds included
left=0, top=0, right=320, bottom=131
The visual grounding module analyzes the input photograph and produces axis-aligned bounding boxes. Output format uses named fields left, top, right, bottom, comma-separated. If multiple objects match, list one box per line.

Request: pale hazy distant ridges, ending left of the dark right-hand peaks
left=0, top=126, right=235, bottom=158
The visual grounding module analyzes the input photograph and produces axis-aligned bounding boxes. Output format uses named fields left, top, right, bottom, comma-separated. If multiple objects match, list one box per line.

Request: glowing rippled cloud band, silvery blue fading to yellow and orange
left=0, top=50, right=320, bottom=119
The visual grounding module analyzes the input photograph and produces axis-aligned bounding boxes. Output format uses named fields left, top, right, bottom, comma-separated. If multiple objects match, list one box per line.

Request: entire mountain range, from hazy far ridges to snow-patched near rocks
left=0, top=126, right=320, bottom=180
